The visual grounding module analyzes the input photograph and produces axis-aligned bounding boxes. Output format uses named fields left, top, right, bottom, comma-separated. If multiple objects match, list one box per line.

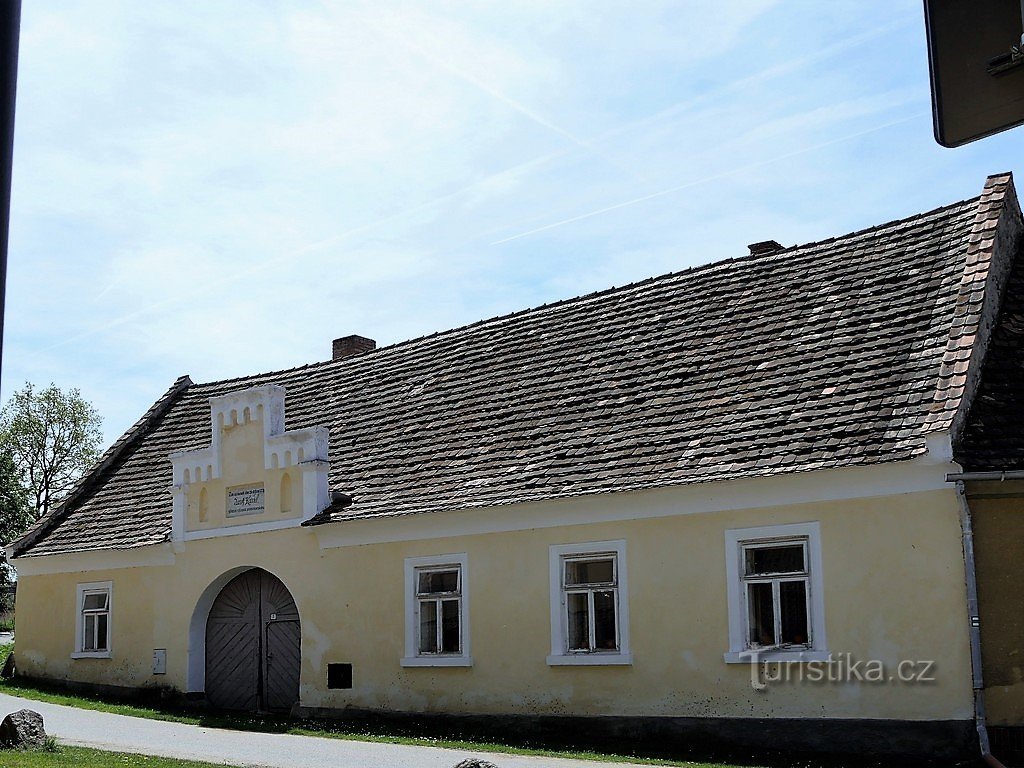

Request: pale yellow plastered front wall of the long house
left=15, top=489, right=972, bottom=720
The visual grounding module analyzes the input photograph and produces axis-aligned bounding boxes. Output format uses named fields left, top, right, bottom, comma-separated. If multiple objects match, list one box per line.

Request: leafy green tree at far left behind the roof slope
left=0, top=383, right=102, bottom=518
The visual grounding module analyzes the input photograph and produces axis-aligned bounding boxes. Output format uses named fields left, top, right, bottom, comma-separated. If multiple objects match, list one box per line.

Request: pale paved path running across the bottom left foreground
left=0, top=693, right=636, bottom=768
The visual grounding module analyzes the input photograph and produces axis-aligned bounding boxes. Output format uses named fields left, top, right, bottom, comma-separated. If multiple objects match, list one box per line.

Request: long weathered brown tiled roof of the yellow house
left=16, top=175, right=1021, bottom=555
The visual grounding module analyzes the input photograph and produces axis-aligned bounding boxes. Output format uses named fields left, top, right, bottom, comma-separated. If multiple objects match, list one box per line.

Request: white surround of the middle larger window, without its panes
left=547, top=540, right=633, bottom=667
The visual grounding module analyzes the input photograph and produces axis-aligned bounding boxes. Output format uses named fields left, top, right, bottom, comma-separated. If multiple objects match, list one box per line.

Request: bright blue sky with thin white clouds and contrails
left=0, top=0, right=1024, bottom=442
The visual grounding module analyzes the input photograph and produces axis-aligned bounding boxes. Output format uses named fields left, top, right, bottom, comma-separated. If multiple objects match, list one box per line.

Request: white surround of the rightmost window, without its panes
left=725, top=521, right=829, bottom=664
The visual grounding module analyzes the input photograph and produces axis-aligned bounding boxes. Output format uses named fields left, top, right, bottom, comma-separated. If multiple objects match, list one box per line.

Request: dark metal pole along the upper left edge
left=0, top=0, right=22, bottom=382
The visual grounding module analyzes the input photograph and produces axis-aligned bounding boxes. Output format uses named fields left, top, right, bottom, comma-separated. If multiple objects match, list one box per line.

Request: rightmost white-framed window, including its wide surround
left=726, top=523, right=827, bottom=662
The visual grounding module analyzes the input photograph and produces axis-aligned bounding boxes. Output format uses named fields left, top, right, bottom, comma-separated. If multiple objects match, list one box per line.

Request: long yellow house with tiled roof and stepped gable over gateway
left=8, top=174, right=1024, bottom=754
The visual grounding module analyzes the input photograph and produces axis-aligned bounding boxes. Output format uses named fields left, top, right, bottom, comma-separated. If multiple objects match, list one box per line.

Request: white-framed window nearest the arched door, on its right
left=401, top=554, right=473, bottom=667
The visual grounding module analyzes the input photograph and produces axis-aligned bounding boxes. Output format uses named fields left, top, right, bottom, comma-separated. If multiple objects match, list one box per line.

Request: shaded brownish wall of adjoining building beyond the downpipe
left=968, top=481, right=1024, bottom=725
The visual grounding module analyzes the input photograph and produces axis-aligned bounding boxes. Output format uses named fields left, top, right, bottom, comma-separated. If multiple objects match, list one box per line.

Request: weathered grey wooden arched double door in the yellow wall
left=206, top=568, right=302, bottom=711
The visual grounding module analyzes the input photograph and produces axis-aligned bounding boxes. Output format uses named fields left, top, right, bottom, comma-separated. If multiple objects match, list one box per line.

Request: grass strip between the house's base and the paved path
left=0, top=645, right=966, bottom=768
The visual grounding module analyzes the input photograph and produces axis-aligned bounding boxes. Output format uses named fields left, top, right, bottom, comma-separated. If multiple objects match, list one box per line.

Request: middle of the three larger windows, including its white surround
left=548, top=541, right=633, bottom=665
